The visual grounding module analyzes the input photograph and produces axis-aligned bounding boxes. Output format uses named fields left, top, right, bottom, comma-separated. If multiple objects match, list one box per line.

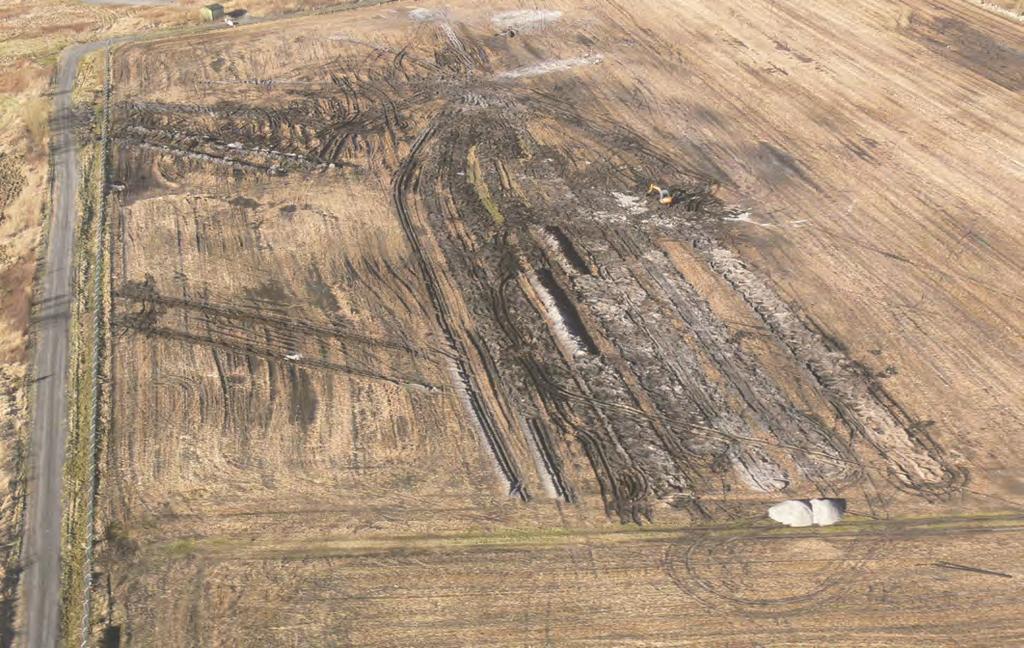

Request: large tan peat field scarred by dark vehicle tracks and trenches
left=83, top=0, right=1024, bottom=646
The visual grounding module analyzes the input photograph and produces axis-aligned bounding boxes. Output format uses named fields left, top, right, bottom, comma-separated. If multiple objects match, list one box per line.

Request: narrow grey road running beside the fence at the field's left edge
left=22, top=41, right=108, bottom=646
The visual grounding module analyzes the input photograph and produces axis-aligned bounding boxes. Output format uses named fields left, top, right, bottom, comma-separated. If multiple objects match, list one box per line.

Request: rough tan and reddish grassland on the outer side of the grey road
left=0, top=0, right=376, bottom=644
